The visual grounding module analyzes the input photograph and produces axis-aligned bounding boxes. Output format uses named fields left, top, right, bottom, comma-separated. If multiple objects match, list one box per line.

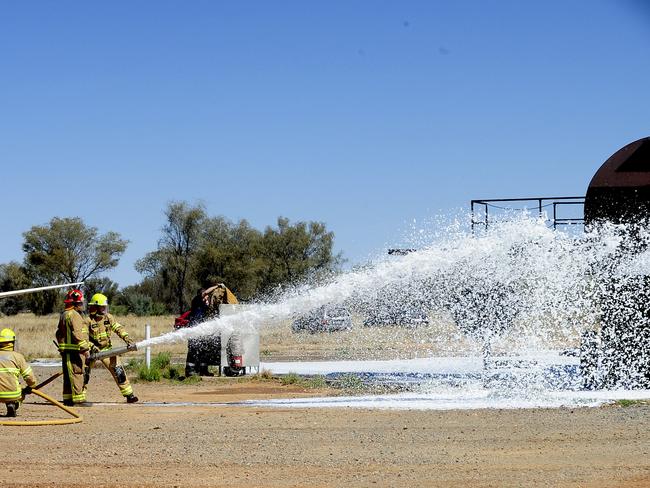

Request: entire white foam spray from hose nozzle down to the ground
left=138, top=215, right=650, bottom=408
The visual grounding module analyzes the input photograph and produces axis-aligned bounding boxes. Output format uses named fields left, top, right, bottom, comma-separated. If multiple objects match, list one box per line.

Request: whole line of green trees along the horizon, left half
left=0, top=201, right=343, bottom=315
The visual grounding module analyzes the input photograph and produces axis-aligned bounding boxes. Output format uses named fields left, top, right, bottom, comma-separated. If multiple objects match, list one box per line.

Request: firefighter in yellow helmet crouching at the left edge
left=0, top=329, right=36, bottom=417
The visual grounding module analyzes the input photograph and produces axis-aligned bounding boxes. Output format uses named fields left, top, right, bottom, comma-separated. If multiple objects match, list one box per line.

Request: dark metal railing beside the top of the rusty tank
left=471, top=197, right=585, bottom=232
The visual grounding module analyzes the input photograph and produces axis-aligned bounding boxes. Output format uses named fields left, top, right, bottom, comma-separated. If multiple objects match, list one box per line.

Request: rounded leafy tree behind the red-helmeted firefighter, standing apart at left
left=23, top=217, right=128, bottom=284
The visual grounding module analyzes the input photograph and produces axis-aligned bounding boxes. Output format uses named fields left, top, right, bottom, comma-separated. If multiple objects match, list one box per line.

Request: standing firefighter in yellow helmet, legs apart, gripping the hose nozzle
left=88, top=293, right=138, bottom=403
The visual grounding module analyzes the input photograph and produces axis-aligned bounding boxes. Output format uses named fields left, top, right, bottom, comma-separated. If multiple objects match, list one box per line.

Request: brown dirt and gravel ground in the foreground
left=0, top=368, right=650, bottom=488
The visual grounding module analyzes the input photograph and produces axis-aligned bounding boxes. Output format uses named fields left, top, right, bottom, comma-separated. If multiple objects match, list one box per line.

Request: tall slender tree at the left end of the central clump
left=136, top=202, right=206, bottom=313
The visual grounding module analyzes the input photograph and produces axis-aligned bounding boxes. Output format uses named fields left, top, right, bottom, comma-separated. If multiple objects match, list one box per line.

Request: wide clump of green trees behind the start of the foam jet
left=133, top=202, right=343, bottom=313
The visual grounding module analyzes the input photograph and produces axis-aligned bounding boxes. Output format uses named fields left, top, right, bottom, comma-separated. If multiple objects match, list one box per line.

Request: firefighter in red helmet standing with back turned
left=56, top=290, right=90, bottom=407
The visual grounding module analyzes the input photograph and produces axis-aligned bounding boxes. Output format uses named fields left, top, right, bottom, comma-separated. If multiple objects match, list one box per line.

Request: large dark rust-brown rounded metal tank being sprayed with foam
left=581, top=137, right=650, bottom=388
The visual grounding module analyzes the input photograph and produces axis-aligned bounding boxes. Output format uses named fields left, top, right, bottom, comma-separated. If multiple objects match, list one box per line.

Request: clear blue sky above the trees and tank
left=0, top=0, right=650, bottom=285
